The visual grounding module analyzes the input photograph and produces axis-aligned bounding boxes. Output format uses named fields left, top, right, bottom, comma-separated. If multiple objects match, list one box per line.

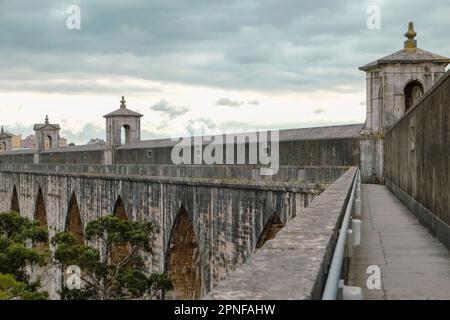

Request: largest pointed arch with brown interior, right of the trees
left=165, top=206, right=202, bottom=299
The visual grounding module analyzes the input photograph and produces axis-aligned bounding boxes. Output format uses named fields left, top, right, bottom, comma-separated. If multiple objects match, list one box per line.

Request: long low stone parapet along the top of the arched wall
left=0, top=163, right=348, bottom=187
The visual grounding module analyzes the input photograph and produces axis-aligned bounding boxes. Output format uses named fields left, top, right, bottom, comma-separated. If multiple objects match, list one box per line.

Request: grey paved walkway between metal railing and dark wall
left=349, top=184, right=450, bottom=300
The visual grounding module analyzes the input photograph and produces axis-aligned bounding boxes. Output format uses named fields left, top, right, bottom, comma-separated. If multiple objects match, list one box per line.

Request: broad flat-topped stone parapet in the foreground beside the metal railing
left=206, top=167, right=356, bottom=300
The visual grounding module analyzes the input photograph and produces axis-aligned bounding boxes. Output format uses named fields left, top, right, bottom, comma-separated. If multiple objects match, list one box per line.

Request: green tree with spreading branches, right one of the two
left=52, top=215, right=173, bottom=300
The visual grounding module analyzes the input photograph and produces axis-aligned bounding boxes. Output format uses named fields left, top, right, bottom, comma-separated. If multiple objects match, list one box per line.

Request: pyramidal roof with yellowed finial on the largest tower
left=359, top=22, right=450, bottom=71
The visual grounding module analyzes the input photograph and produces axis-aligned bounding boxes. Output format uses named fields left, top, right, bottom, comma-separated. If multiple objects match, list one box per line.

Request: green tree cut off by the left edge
left=0, top=212, right=49, bottom=299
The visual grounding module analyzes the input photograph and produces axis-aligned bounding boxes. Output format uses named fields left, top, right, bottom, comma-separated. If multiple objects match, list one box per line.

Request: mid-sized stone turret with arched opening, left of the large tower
left=104, top=96, right=142, bottom=164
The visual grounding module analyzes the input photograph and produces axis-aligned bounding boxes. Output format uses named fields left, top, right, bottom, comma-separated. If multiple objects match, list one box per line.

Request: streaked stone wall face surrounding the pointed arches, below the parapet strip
left=0, top=165, right=334, bottom=295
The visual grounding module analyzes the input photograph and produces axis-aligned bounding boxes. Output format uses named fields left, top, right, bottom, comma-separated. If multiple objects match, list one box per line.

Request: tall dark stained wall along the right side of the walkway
left=384, top=72, right=450, bottom=225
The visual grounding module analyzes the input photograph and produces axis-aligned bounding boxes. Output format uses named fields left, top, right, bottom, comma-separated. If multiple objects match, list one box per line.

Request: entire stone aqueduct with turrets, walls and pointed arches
left=0, top=24, right=450, bottom=299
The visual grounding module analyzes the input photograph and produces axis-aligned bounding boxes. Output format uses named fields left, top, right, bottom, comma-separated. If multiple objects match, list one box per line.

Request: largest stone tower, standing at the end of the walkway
left=359, top=22, right=450, bottom=183
